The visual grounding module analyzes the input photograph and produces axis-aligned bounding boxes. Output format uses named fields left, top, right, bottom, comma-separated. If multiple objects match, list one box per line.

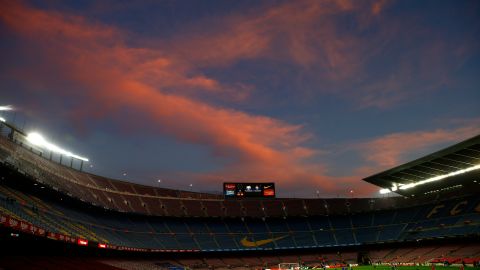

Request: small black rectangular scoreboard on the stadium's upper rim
left=223, top=183, right=275, bottom=198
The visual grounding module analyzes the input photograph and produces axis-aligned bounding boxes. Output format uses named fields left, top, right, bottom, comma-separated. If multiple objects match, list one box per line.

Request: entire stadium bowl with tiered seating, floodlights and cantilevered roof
left=0, top=119, right=480, bottom=269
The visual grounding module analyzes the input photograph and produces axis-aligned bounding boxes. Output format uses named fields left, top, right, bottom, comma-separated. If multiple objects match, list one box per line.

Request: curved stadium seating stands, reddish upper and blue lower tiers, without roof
left=0, top=123, right=480, bottom=269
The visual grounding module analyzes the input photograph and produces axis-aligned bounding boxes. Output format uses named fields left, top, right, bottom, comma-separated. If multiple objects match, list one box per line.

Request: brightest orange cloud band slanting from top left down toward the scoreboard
left=0, top=0, right=358, bottom=194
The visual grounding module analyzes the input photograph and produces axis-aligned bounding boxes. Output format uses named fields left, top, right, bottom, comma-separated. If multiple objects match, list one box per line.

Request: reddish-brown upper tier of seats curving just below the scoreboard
left=0, top=136, right=432, bottom=217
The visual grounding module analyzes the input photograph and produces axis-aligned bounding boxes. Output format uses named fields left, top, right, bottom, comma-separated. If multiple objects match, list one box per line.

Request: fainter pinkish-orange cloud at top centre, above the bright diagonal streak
left=165, top=0, right=386, bottom=76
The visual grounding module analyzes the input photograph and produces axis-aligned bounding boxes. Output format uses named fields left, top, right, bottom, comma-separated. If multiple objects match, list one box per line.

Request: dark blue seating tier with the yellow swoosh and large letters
left=0, top=173, right=480, bottom=251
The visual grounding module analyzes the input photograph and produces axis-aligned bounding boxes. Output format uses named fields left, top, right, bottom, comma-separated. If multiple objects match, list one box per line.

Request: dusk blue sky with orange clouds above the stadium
left=0, top=0, right=480, bottom=197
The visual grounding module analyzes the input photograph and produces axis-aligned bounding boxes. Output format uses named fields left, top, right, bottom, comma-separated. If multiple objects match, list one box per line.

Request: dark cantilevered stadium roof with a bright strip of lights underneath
left=363, top=135, right=480, bottom=196
